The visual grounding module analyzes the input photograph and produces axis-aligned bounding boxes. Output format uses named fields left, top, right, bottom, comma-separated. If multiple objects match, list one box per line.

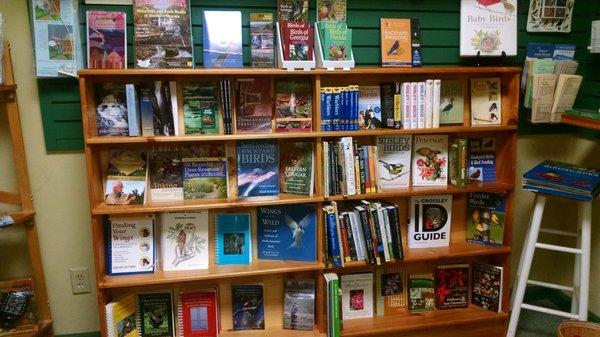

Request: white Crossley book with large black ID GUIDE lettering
left=408, top=195, right=452, bottom=248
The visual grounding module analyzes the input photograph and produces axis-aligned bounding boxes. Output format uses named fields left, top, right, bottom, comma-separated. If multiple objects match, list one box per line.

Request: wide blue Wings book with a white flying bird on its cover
left=256, top=204, right=317, bottom=262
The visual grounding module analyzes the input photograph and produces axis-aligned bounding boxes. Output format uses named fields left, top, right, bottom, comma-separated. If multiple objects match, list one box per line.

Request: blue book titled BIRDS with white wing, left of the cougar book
left=237, top=140, right=279, bottom=199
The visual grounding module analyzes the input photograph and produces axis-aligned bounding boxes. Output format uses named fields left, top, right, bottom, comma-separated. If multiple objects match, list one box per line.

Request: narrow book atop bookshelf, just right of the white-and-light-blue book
left=250, top=13, right=275, bottom=68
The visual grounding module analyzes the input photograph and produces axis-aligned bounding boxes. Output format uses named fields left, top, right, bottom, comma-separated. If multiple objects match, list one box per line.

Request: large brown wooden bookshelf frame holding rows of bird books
left=79, top=66, right=520, bottom=337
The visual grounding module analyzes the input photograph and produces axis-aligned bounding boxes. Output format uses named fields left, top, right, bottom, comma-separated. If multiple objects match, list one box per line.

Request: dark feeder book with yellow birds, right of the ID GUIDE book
left=467, top=192, right=506, bottom=246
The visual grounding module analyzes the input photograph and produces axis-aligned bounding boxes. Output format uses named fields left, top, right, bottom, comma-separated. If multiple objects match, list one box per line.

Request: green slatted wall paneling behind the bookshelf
left=38, top=0, right=600, bottom=150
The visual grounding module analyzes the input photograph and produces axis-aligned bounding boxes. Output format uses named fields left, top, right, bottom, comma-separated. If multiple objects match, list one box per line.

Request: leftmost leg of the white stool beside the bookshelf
left=506, top=194, right=546, bottom=337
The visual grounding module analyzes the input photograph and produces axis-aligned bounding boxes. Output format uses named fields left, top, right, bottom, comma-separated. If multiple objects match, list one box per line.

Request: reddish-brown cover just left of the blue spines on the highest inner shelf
left=275, top=79, right=313, bottom=132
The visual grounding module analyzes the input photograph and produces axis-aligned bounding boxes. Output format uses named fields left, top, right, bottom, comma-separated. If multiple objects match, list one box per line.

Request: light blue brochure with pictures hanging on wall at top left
left=30, top=0, right=81, bottom=77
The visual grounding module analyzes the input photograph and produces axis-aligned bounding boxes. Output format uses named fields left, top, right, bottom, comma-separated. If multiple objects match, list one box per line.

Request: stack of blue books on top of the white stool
left=523, top=160, right=600, bottom=201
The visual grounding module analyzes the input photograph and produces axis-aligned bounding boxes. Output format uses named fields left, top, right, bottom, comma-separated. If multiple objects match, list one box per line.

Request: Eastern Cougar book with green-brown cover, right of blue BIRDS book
left=279, top=143, right=315, bottom=196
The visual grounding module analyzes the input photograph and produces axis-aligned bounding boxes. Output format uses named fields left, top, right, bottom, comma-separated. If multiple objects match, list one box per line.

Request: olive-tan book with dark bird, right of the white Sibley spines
left=439, top=79, right=465, bottom=124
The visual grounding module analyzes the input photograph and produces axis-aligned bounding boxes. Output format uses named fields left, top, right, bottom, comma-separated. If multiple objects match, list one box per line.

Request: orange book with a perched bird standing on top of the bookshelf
left=380, top=18, right=412, bottom=67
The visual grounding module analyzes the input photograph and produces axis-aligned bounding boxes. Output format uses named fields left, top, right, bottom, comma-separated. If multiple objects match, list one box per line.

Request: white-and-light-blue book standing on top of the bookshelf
left=202, top=10, right=243, bottom=68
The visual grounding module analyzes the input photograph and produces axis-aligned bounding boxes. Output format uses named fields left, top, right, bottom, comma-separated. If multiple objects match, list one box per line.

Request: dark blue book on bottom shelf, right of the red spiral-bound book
left=231, top=284, right=265, bottom=331
